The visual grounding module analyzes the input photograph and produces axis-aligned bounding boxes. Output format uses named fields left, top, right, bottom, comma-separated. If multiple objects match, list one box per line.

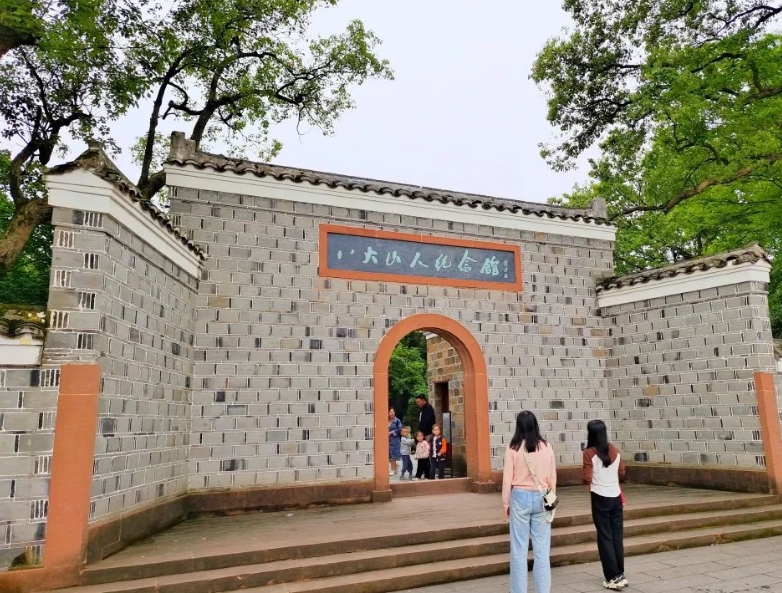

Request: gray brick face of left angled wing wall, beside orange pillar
left=44, top=208, right=198, bottom=521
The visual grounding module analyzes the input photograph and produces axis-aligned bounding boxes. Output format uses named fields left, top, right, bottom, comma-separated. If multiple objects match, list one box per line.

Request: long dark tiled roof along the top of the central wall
left=166, top=132, right=612, bottom=226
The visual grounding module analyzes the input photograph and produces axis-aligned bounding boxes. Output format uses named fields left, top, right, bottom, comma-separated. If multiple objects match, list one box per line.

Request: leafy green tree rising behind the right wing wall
left=532, top=0, right=782, bottom=332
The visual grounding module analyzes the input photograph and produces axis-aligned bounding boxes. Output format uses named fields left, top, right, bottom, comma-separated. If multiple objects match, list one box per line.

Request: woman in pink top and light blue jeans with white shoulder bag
left=502, top=411, right=557, bottom=593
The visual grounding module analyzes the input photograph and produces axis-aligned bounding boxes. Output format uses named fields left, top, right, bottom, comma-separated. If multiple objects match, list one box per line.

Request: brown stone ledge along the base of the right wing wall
left=627, top=463, right=771, bottom=494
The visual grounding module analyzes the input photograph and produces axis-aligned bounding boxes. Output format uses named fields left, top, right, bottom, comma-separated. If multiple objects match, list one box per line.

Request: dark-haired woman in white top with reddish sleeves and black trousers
left=583, top=420, right=628, bottom=590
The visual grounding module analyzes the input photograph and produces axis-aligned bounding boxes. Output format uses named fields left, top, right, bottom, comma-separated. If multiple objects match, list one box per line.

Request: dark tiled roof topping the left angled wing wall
left=46, top=144, right=206, bottom=260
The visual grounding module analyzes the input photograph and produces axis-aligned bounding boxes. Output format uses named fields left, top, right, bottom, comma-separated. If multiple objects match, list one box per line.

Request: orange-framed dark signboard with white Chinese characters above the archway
left=321, top=227, right=519, bottom=288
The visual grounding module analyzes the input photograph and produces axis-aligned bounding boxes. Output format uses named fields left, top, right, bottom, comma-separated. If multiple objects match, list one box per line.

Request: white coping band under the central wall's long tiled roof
left=163, top=163, right=616, bottom=241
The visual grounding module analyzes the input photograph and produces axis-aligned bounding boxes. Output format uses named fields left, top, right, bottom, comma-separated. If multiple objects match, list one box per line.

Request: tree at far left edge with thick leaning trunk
left=0, top=0, right=144, bottom=278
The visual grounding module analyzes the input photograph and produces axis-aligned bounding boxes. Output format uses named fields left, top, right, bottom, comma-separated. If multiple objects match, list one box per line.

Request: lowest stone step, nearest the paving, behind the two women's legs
left=61, top=520, right=782, bottom=593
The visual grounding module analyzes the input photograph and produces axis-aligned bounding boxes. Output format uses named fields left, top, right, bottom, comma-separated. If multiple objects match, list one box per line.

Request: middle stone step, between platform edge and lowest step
left=62, top=505, right=782, bottom=593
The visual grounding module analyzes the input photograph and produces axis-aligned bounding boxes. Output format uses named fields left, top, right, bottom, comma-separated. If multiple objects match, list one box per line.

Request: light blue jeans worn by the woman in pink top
left=510, top=488, right=551, bottom=593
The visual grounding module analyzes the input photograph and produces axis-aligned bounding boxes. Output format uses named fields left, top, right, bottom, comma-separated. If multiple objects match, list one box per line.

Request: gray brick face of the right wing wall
left=602, top=282, right=775, bottom=468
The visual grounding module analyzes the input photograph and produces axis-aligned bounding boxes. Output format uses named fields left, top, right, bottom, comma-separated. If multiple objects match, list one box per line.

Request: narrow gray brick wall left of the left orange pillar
left=0, top=367, right=60, bottom=570
